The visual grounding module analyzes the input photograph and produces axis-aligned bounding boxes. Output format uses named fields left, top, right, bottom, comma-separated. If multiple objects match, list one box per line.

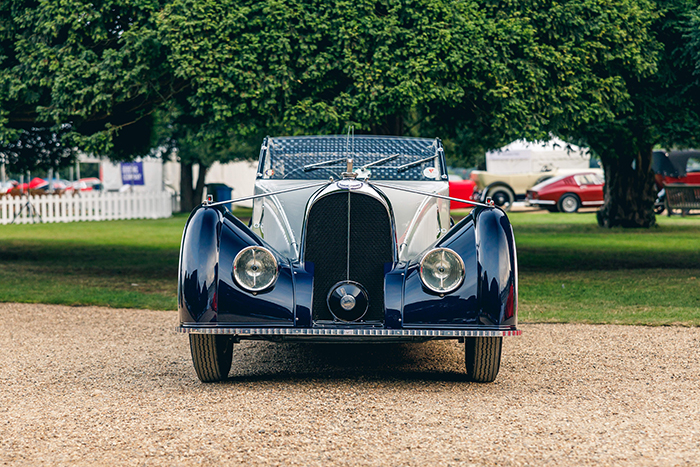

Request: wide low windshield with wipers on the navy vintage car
left=258, top=135, right=446, bottom=180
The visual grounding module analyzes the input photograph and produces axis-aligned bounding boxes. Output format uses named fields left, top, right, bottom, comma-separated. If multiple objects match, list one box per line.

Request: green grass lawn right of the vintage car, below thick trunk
left=509, top=212, right=700, bottom=326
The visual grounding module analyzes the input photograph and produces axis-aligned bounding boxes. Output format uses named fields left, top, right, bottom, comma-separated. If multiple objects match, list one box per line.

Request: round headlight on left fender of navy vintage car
left=233, top=246, right=277, bottom=292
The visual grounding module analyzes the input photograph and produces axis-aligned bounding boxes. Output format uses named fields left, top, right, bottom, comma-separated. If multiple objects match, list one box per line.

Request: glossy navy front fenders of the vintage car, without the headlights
left=178, top=201, right=517, bottom=329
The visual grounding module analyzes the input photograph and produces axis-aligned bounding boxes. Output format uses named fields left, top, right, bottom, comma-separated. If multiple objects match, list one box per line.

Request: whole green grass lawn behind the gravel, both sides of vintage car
left=0, top=211, right=700, bottom=326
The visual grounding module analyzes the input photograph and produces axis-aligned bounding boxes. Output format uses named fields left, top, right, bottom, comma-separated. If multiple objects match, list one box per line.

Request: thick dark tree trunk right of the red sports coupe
left=597, top=146, right=656, bottom=228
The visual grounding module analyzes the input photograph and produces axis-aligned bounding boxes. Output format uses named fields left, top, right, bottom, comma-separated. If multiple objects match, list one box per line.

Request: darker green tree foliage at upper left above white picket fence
left=0, top=0, right=179, bottom=158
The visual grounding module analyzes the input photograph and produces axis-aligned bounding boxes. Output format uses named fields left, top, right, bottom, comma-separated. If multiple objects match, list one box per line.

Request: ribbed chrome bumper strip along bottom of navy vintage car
left=177, top=326, right=523, bottom=338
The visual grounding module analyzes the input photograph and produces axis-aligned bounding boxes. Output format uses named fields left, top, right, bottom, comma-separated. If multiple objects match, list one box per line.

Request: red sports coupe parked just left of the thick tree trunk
left=525, top=172, right=605, bottom=212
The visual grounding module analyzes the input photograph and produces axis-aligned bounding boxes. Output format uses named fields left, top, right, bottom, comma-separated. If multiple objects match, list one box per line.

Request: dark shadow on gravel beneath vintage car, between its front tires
left=221, top=342, right=466, bottom=383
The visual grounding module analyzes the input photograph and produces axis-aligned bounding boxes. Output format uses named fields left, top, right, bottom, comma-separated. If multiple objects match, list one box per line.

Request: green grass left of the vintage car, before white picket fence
left=0, top=216, right=187, bottom=310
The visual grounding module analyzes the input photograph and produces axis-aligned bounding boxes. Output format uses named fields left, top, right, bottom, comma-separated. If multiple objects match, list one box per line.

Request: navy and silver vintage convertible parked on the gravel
left=178, top=136, right=521, bottom=382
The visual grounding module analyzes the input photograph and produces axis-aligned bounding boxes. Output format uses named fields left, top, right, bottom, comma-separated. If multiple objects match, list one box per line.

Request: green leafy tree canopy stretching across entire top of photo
left=0, top=0, right=700, bottom=224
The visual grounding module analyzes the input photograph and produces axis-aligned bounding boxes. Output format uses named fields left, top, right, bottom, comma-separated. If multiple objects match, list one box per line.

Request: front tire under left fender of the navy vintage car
left=190, top=334, right=233, bottom=383
